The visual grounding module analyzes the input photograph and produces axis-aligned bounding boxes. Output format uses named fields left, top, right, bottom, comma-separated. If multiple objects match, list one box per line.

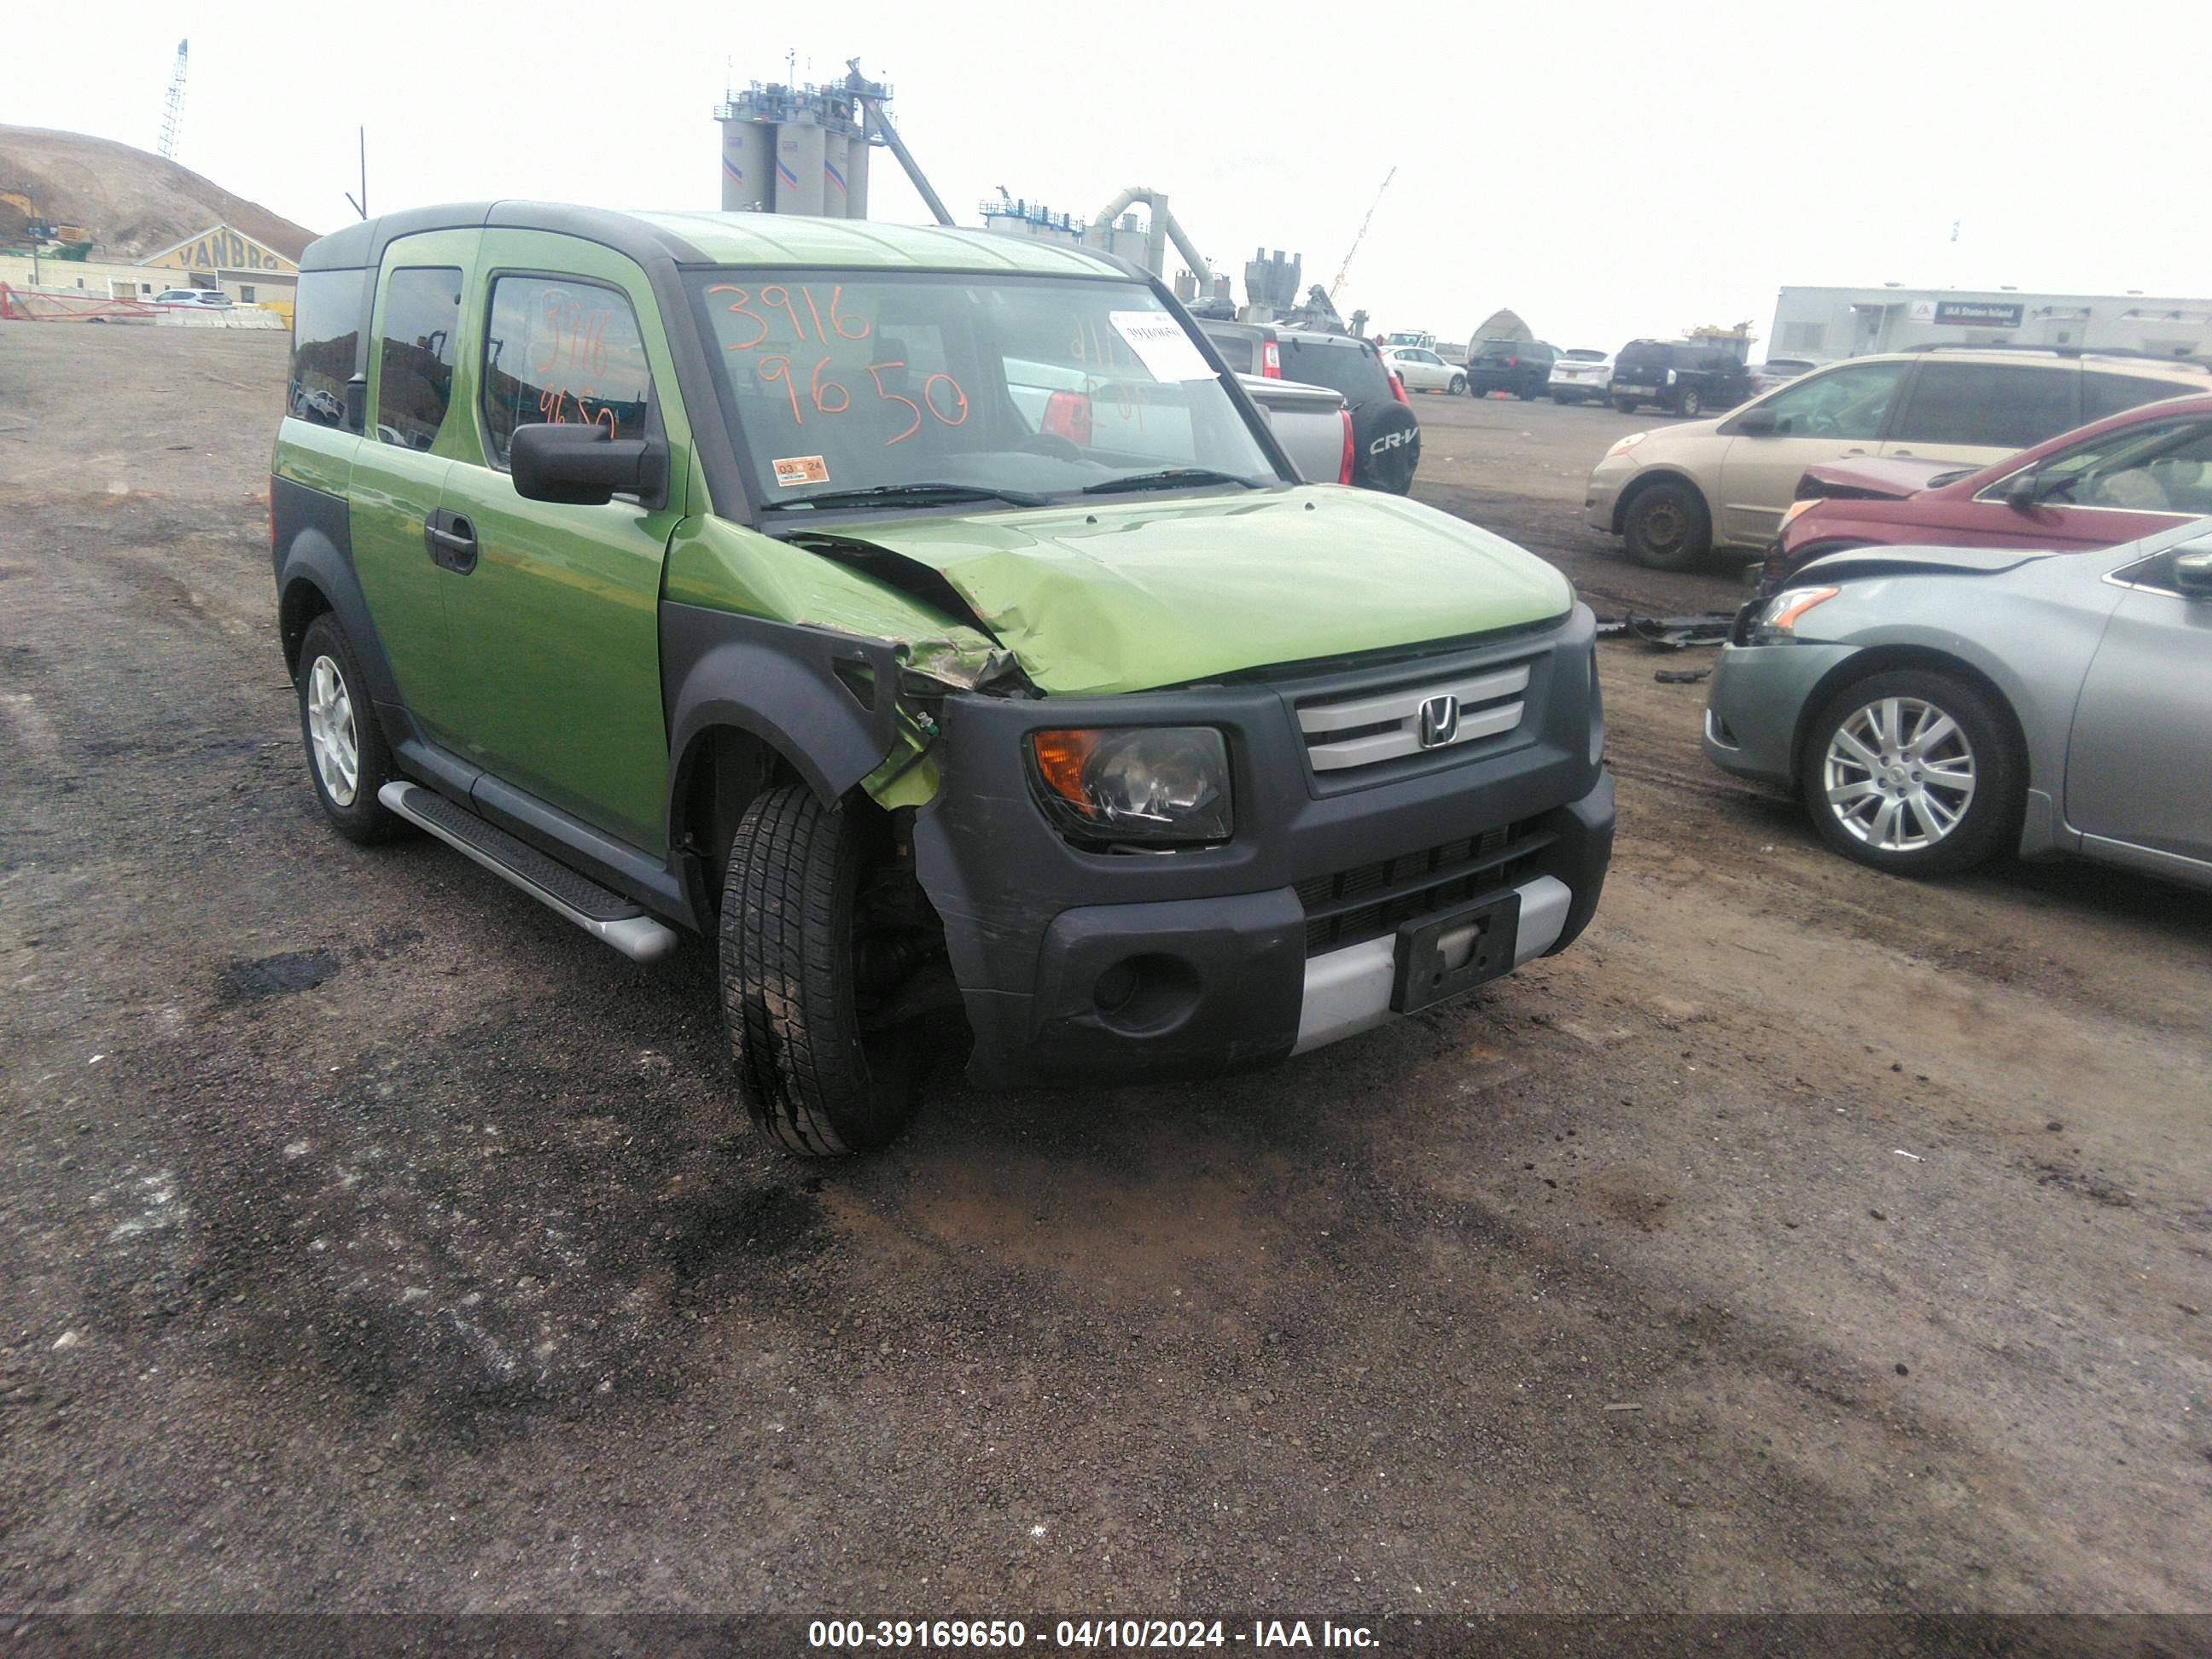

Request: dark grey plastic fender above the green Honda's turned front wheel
left=661, top=602, right=898, bottom=834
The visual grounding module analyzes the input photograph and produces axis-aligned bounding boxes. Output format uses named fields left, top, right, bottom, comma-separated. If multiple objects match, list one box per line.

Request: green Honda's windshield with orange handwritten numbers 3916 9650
left=692, top=270, right=1281, bottom=509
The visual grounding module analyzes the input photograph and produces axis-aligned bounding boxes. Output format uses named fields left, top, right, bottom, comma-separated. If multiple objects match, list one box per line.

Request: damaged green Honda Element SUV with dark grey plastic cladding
left=272, top=201, right=1613, bottom=1155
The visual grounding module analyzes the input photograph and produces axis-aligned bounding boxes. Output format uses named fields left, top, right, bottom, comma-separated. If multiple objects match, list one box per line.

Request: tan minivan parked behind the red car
left=1584, top=347, right=2212, bottom=571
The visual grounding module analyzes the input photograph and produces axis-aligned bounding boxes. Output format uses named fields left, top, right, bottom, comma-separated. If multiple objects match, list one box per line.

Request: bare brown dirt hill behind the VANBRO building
left=0, top=124, right=317, bottom=259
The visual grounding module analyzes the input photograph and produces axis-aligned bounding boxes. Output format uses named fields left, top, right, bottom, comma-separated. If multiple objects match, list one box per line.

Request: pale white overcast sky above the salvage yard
left=0, top=0, right=2212, bottom=356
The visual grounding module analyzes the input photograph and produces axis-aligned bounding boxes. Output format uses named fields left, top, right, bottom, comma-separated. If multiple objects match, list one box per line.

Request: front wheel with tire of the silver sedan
left=1798, top=668, right=2026, bottom=876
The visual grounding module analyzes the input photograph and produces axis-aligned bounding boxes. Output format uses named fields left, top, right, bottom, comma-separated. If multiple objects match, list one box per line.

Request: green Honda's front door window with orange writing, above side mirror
left=485, top=276, right=653, bottom=467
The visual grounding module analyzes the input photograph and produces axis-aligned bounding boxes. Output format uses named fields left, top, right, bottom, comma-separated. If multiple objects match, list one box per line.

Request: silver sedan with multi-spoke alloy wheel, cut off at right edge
left=1705, top=520, right=2212, bottom=887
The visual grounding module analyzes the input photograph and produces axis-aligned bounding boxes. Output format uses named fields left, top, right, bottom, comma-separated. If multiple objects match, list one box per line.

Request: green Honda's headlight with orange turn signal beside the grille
left=1028, top=725, right=1237, bottom=845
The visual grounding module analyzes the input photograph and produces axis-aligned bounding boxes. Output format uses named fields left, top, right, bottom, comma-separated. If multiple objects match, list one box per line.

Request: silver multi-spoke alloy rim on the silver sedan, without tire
left=1820, top=696, right=1976, bottom=852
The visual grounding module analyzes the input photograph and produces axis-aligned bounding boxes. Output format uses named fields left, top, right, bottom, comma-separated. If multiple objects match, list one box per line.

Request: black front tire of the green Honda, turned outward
left=721, top=783, right=927, bottom=1157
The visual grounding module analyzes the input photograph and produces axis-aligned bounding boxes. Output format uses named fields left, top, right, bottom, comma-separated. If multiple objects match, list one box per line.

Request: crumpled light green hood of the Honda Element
left=813, top=486, right=1575, bottom=696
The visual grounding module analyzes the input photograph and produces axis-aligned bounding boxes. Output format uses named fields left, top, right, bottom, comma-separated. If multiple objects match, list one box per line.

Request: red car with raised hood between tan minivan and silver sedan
left=1761, top=396, right=2212, bottom=591
